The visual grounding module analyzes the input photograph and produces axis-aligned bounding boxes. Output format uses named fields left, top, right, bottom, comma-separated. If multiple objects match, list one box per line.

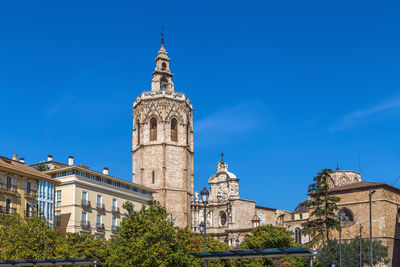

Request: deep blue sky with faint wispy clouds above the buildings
left=0, top=0, right=400, bottom=213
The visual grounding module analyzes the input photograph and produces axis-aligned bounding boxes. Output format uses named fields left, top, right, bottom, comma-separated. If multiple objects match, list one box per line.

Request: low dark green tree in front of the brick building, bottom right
left=318, top=240, right=389, bottom=267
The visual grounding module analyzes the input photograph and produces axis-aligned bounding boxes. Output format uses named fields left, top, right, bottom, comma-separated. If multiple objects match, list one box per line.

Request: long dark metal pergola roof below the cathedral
left=190, top=247, right=318, bottom=266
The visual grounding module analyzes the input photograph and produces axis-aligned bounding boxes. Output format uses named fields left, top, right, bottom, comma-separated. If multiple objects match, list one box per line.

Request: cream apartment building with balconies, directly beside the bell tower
left=32, top=156, right=155, bottom=239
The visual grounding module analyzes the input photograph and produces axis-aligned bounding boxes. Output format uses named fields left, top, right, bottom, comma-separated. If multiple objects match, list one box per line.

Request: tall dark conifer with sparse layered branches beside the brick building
left=302, top=169, right=340, bottom=247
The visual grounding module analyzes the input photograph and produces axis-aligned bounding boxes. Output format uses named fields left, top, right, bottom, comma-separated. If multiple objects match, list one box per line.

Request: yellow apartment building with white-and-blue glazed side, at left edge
left=0, top=155, right=60, bottom=226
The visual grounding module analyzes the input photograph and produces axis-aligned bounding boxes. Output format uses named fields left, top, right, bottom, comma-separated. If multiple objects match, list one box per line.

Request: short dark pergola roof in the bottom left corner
left=0, top=259, right=97, bottom=266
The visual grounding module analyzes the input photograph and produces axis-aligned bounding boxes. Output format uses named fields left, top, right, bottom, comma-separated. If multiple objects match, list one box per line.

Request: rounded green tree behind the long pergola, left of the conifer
left=236, top=225, right=308, bottom=267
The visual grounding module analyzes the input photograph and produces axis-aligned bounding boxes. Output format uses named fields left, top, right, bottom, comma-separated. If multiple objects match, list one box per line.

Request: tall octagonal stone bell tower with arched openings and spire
left=132, top=39, right=193, bottom=227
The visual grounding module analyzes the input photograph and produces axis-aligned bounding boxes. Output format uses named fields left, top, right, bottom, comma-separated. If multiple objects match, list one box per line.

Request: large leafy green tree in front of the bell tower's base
left=108, top=201, right=191, bottom=266
